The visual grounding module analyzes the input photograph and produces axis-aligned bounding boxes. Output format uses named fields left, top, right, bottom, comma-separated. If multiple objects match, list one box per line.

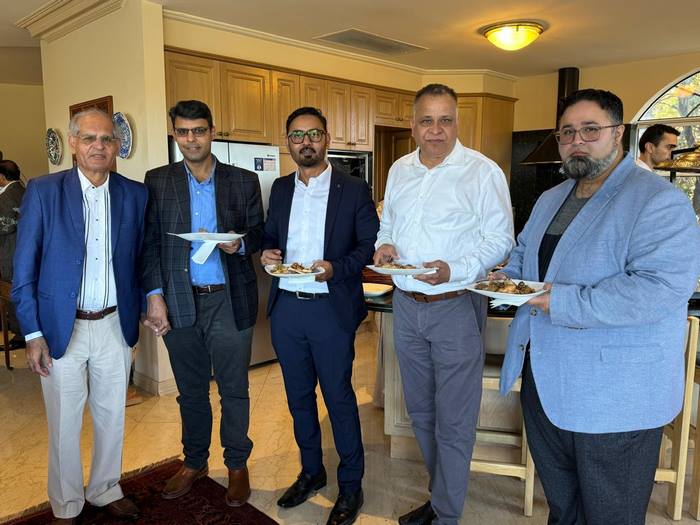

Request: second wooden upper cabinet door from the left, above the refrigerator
left=220, top=64, right=273, bottom=144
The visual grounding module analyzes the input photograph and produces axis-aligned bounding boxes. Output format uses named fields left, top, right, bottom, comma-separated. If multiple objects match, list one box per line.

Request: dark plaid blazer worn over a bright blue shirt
left=141, top=161, right=263, bottom=330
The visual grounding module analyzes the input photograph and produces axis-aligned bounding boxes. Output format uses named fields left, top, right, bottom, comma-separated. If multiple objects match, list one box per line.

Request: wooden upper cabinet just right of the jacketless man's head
left=457, top=94, right=515, bottom=176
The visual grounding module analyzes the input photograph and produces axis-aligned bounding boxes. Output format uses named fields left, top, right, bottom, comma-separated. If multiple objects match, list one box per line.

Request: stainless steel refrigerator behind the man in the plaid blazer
left=169, top=138, right=280, bottom=365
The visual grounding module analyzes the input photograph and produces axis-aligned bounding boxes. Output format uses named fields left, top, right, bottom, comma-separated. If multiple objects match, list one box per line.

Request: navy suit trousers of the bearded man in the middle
left=270, top=293, right=364, bottom=492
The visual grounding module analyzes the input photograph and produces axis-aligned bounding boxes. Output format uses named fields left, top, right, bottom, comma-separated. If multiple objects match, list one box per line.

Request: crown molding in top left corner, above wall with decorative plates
left=15, top=0, right=126, bottom=42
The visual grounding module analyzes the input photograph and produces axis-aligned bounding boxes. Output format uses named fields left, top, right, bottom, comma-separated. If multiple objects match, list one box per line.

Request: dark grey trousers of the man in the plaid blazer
left=164, top=290, right=253, bottom=469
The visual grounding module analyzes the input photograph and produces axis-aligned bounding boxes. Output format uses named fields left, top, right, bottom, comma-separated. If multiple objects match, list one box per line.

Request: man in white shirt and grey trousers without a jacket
left=374, top=84, right=514, bottom=525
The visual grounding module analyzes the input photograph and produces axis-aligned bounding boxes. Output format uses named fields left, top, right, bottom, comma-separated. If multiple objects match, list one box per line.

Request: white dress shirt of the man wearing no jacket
left=376, top=141, right=514, bottom=295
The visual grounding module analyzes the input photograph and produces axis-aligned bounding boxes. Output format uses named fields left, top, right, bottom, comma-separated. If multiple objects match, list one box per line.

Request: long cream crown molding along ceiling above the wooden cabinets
left=163, top=9, right=518, bottom=82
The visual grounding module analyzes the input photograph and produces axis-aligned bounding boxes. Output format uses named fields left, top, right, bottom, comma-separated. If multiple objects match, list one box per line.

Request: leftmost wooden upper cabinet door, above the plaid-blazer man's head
left=165, top=51, right=222, bottom=133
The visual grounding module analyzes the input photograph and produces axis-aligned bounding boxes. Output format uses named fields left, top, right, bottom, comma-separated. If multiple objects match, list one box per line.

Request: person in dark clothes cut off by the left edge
left=0, top=160, right=24, bottom=348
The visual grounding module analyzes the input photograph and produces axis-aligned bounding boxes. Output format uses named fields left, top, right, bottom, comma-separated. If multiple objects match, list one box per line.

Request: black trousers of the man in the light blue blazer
left=520, top=356, right=663, bottom=525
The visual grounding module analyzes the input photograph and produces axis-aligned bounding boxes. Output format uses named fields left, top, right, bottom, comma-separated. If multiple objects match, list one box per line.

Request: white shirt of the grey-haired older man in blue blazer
left=25, top=168, right=117, bottom=341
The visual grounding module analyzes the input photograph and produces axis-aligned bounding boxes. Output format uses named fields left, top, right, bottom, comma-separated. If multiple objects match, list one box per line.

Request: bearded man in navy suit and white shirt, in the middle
left=261, top=107, right=379, bottom=525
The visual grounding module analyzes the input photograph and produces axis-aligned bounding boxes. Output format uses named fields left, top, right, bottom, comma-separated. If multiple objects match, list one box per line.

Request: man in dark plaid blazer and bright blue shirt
left=142, top=100, right=263, bottom=507
